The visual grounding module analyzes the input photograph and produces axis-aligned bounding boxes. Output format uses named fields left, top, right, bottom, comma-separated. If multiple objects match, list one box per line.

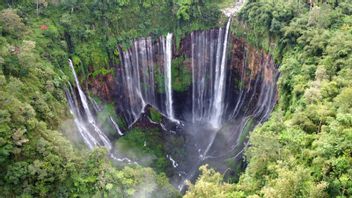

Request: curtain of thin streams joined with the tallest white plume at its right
left=191, top=19, right=231, bottom=128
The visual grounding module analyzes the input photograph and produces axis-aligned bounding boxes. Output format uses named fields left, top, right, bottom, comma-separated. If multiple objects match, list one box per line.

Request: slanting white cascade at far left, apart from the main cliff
left=69, top=60, right=112, bottom=150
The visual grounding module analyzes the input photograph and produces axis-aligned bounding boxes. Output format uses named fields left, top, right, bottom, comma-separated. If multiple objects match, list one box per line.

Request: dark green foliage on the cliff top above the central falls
left=1, top=0, right=220, bottom=78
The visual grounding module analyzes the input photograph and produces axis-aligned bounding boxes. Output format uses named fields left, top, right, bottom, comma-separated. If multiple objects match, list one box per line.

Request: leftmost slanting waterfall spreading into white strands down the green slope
left=66, top=60, right=112, bottom=150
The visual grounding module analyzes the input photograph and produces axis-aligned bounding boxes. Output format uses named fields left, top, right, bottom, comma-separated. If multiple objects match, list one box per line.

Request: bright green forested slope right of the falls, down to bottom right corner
left=186, top=0, right=352, bottom=197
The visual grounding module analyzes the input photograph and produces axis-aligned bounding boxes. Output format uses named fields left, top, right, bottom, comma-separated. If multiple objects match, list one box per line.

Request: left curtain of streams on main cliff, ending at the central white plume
left=116, top=33, right=177, bottom=126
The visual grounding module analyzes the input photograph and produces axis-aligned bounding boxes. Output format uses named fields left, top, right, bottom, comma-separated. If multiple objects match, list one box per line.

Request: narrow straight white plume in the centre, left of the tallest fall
left=164, top=33, right=175, bottom=120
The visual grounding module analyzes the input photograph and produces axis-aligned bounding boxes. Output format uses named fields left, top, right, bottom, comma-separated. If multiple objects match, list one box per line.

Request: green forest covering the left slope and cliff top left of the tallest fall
left=0, top=0, right=228, bottom=197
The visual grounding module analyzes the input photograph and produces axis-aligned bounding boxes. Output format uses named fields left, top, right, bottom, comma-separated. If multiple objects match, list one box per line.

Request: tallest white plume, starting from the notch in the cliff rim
left=210, top=17, right=231, bottom=129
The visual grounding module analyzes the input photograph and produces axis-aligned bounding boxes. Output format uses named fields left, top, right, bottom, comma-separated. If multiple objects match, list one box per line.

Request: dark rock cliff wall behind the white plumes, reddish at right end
left=88, top=29, right=278, bottom=126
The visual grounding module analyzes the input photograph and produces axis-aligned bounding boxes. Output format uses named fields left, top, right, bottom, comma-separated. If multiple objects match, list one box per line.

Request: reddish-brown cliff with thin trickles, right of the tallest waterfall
left=225, top=36, right=279, bottom=120
